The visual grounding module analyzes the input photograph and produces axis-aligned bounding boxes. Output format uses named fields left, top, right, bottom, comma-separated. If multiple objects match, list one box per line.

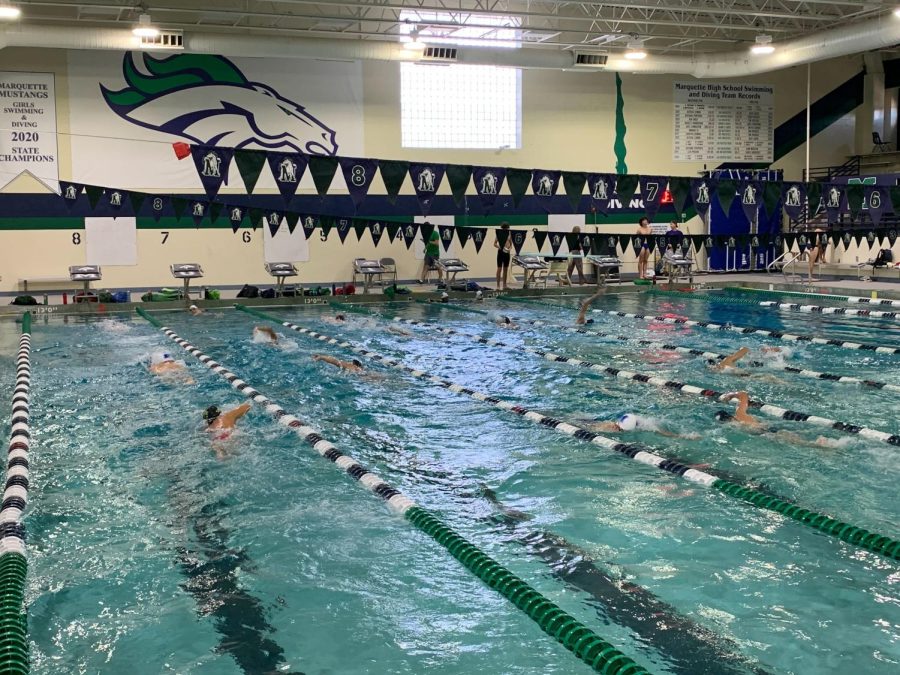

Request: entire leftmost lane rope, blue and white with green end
left=0, top=312, right=31, bottom=675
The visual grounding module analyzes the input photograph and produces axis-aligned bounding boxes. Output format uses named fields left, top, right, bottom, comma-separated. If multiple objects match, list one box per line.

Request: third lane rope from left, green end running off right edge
left=235, top=305, right=900, bottom=560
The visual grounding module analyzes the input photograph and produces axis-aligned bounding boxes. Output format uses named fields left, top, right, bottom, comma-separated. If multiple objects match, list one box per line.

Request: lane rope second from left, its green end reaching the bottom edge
left=136, top=307, right=650, bottom=675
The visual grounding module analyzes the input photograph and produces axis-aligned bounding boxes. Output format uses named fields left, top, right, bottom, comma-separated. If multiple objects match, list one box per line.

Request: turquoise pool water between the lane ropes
left=0, top=296, right=900, bottom=675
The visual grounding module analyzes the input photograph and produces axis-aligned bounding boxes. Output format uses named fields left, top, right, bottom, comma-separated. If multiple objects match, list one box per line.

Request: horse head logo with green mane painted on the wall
left=100, top=52, right=338, bottom=155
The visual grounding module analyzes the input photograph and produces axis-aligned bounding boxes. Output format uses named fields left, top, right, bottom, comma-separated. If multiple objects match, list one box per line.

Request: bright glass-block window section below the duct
left=400, top=63, right=522, bottom=148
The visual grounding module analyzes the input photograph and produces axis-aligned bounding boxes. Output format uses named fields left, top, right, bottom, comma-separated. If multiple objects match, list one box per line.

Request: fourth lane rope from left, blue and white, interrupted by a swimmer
left=384, top=316, right=900, bottom=447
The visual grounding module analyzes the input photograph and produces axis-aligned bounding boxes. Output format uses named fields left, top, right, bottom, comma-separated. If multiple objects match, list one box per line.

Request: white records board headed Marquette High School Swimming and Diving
left=672, top=82, right=775, bottom=162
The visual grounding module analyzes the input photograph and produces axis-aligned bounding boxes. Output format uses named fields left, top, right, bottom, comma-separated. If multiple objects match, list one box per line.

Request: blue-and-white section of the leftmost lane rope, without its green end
left=0, top=321, right=31, bottom=556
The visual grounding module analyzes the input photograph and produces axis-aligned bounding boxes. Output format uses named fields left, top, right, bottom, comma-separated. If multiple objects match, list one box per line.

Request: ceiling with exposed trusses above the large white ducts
left=10, top=0, right=898, bottom=54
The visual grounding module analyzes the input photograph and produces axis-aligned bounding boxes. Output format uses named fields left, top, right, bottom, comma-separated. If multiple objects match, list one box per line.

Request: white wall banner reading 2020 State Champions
left=0, top=72, right=59, bottom=192
